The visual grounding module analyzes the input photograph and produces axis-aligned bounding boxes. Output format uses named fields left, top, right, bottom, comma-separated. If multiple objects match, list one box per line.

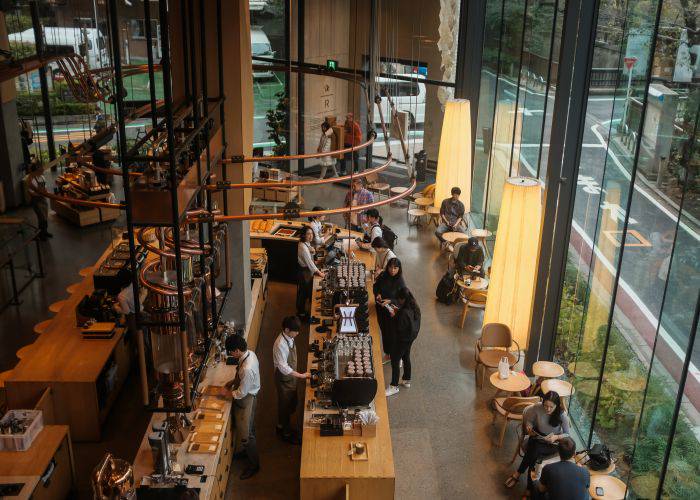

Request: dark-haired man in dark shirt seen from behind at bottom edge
left=535, top=437, right=591, bottom=500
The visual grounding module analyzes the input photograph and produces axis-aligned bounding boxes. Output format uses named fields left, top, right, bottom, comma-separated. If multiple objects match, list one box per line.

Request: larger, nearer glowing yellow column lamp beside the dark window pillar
left=484, top=177, right=542, bottom=349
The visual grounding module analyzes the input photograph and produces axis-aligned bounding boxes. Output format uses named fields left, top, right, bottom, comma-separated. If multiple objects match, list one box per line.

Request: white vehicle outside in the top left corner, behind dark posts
left=8, top=26, right=110, bottom=72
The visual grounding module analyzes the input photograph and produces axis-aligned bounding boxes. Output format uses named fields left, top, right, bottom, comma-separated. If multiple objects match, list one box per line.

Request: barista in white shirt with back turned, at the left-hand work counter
left=222, top=335, right=260, bottom=480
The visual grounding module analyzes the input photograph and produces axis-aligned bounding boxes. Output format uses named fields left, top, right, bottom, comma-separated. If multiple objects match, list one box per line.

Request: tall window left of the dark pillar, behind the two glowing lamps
left=471, top=0, right=566, bottom=244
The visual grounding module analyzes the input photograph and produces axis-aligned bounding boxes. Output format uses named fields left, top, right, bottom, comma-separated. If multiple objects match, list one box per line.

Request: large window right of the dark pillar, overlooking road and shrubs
left=555, top=0, right=700, bottom=498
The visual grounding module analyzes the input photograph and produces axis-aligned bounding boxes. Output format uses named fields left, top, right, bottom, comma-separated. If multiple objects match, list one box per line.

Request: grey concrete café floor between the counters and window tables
left=0, top=187, right=521, bottom=499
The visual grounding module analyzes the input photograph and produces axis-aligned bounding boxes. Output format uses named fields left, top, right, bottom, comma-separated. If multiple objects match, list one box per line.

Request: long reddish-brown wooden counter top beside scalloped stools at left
left=8, top=240, right=124, bottom=385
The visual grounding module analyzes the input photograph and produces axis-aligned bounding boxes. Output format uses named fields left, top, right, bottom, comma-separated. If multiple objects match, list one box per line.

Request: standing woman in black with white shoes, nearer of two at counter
left=386, top=287, right=421, bottom=396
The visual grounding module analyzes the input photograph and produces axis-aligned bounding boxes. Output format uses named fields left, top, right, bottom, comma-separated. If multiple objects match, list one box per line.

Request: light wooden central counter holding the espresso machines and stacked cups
left=300, top=244, right=395, bottom=499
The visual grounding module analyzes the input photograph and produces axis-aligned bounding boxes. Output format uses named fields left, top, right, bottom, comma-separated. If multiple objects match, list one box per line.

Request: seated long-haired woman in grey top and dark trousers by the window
left=505, top=391, right=569, bottom=488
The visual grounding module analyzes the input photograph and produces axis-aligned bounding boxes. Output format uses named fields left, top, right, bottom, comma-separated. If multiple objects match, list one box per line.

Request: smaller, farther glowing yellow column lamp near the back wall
left=435, top=99, right=472, bottom=211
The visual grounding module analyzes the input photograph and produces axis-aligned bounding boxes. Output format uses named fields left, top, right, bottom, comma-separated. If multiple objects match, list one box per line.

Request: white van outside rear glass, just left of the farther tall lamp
left=374, top=74, right=425, bottom=128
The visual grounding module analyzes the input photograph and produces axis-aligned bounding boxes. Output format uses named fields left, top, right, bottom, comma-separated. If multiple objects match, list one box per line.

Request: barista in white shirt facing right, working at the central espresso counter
left=272, top=316, right=311, bottom=444
